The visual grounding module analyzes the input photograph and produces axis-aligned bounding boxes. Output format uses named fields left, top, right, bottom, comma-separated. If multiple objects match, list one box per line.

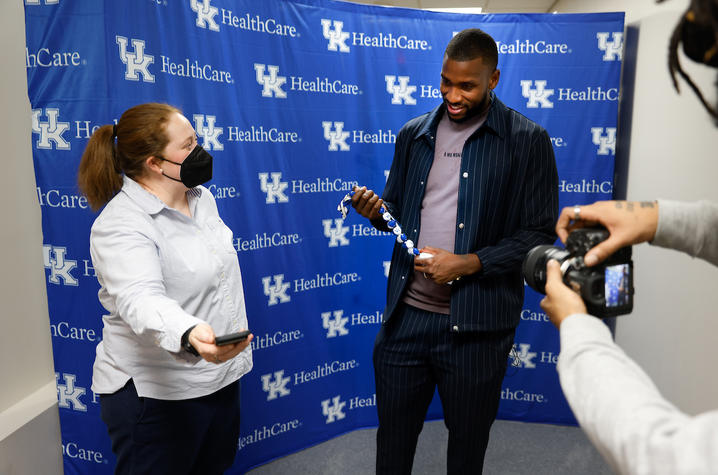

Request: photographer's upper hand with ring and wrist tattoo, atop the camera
left=556, top=201, right=658, bottom=266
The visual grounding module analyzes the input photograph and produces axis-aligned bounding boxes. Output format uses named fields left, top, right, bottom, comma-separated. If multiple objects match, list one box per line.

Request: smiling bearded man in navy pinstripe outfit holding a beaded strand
left=352, top=29, right=558, bottom=474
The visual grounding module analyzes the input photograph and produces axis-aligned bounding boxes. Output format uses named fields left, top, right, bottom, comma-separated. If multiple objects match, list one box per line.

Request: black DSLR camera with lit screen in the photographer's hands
left=523, top=227, right=633, bottom=318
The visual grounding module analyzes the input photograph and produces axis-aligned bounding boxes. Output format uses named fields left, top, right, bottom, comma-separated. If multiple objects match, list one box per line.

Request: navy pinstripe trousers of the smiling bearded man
left=373, top=304, right=515, bottom=475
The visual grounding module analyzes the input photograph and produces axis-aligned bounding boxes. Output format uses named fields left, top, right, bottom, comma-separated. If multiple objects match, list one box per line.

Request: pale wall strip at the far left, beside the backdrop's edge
left=0, top=0, right=62, bottom=474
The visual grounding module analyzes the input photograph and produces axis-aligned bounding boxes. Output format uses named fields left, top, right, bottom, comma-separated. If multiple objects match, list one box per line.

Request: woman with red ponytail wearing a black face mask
left=78, top=103, right=252, bottom=474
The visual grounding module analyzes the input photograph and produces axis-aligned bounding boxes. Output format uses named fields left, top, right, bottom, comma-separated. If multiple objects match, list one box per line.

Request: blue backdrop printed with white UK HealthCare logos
left=25, top=0, right=623, bottom=474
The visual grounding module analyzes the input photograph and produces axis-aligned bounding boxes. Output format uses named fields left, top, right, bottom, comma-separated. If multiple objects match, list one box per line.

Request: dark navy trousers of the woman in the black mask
left=100, top=379, right=239, bottom=475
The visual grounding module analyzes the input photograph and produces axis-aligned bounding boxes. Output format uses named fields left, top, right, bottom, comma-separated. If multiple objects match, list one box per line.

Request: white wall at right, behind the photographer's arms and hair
left=555, top=0, right=718, bottom=414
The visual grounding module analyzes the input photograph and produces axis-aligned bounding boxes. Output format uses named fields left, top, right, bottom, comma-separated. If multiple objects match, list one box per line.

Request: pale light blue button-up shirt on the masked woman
left=90, top=177, right=252, bottom=400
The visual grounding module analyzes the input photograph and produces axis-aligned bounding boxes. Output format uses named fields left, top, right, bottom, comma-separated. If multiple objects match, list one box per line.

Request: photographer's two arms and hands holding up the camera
left=541, top=201, right=718, bottom=474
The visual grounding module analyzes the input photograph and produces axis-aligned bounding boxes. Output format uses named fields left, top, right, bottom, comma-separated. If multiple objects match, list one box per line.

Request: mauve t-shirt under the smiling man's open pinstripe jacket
left=403, top=111, right=488, bottom=315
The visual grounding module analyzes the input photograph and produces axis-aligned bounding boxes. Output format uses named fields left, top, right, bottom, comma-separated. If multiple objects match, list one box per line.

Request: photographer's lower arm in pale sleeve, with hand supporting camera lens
left=541, top=261, right=718, bottom=473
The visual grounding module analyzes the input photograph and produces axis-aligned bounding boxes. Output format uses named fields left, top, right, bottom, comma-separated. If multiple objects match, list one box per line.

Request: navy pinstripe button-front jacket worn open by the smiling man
left=380, top=92, right=558, bottom=332
